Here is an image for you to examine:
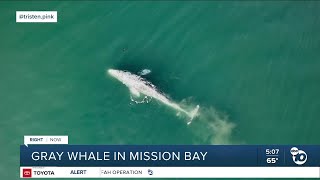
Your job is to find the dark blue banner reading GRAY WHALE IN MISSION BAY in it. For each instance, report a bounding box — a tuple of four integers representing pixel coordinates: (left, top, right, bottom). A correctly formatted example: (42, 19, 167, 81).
(20, 145, 320, 167)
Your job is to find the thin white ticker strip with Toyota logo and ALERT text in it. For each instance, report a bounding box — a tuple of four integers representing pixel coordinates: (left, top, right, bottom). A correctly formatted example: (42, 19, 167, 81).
(20, 167, 320, 178)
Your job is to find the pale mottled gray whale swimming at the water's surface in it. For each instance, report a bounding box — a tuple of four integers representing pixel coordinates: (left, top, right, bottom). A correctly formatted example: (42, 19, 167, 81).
(107, 69, 200, 124)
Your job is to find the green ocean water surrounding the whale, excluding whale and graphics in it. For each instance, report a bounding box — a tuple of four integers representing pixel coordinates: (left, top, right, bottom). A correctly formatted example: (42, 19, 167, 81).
(0, 1, 320, 180)
